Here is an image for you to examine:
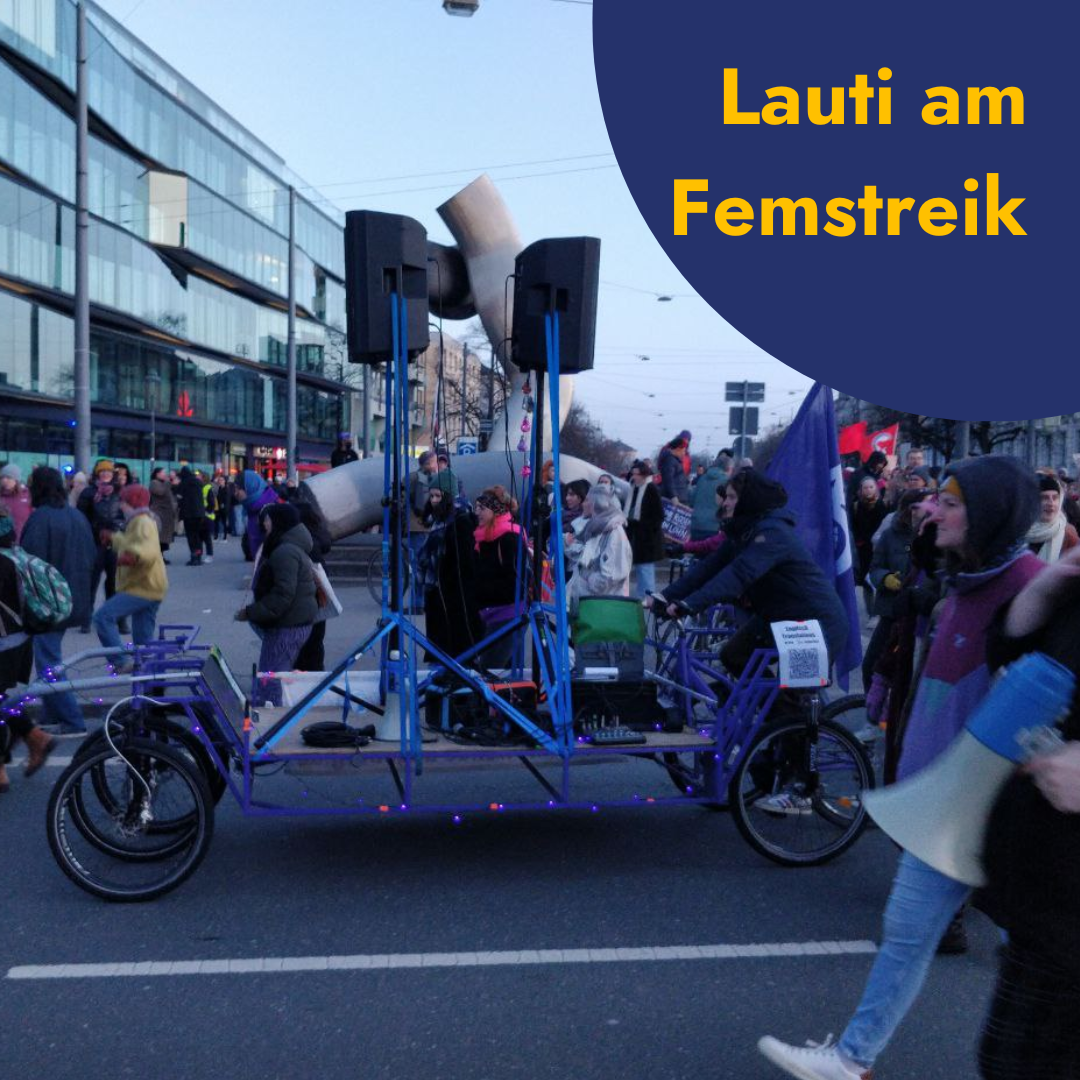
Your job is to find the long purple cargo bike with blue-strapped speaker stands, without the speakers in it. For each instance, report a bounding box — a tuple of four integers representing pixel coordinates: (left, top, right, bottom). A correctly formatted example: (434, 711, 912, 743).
(48, 282, 874, 901)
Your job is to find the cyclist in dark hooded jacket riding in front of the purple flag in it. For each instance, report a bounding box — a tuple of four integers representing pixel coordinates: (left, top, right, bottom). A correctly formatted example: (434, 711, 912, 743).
(645, 468, 849, 674)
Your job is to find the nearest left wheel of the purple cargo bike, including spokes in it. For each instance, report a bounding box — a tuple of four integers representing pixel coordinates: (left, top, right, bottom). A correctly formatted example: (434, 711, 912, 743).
(46, 739, 214, 901)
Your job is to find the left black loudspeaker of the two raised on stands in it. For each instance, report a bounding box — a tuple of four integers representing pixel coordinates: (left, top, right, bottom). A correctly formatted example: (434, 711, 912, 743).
(345, 210, 428, 364)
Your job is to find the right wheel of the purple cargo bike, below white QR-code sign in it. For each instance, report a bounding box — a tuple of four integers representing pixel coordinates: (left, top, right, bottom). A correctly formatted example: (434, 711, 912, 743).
(728, 719, 874, 866)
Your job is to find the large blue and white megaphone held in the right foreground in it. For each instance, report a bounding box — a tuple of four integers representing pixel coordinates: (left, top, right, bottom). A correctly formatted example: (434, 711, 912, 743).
(864, 652, 1076, 888)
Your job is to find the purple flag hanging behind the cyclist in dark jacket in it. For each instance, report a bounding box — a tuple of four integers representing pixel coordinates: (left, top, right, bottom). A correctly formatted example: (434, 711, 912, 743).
(766, 382, 863, 689)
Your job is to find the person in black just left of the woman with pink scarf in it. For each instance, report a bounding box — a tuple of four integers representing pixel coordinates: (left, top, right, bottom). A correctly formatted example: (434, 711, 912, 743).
(416, 487, 484, 660)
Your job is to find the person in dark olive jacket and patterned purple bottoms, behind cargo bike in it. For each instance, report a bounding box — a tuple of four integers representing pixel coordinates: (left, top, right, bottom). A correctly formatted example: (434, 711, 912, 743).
(235, 502, 319, 682)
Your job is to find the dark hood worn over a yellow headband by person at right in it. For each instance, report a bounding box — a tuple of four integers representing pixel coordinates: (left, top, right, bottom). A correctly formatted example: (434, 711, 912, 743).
(950, 454, 1039, 564)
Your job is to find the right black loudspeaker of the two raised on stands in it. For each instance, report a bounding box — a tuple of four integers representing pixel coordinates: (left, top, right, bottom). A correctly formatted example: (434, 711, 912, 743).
(511, 237, 600, 375)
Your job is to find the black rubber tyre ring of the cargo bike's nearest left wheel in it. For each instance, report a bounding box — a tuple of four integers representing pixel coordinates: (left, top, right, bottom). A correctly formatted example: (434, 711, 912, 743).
(46, 739, 214, 903)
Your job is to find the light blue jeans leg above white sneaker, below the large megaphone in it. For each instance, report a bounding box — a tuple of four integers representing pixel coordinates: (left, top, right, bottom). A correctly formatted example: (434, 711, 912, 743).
(839, 851, 971, 1067)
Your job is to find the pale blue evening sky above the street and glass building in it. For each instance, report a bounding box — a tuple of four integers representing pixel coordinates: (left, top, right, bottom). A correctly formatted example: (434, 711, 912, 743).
(97, 0, 811, 454)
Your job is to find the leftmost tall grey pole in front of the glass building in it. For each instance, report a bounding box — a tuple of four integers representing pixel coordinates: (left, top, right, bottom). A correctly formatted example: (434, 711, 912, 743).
(75, 0, 91, 476)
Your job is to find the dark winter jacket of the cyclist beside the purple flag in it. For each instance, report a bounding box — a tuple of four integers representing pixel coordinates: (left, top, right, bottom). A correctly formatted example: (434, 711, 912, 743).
(664, 510, 848, 660)
